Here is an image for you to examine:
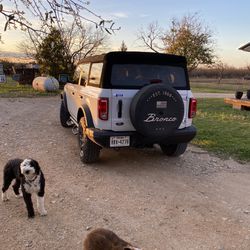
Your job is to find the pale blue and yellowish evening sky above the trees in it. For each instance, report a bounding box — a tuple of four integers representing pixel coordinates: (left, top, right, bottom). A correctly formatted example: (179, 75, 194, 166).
(0, 0, 250, 67)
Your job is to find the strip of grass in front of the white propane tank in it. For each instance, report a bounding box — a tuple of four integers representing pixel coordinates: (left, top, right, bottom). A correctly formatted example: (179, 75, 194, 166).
(0, 77, 59, 98)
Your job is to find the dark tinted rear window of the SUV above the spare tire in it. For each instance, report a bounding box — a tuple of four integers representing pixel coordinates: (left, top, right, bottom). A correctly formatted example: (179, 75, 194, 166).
(111, 64, 187, 88)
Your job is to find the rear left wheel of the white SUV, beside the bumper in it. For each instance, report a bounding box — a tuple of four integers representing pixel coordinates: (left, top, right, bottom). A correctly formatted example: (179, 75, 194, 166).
(78, 117, 101, 163)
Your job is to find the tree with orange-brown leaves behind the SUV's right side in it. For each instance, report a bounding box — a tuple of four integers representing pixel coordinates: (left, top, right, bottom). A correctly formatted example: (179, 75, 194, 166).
(163, 14, 215, 71)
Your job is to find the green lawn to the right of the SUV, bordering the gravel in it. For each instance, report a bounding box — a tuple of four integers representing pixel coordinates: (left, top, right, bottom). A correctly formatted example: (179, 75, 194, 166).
(192, 99, 250, 161)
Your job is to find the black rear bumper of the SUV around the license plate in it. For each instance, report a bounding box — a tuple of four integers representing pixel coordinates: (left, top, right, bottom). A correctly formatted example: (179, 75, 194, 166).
(86, 126, 196, 148)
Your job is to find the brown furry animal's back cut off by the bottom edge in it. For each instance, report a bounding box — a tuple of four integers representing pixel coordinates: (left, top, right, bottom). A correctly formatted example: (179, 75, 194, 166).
(83, 228, 142, 250)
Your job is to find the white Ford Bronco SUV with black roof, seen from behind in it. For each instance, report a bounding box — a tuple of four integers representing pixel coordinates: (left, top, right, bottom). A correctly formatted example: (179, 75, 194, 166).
(60, 52, 196, 163)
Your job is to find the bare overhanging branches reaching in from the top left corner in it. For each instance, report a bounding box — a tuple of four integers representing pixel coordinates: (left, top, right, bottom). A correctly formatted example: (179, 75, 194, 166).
(0, 0, 120, 41)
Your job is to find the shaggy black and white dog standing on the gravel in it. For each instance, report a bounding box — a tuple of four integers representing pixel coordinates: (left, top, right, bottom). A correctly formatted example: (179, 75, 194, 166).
(2, 159, 47, 218)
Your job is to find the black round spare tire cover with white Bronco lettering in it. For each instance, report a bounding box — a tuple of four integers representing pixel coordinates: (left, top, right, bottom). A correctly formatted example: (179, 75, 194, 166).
(130, 84, 184, 137)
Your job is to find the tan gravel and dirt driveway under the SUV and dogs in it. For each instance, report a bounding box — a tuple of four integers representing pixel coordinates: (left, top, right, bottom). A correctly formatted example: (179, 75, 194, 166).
(0, 96, 250, 250)
